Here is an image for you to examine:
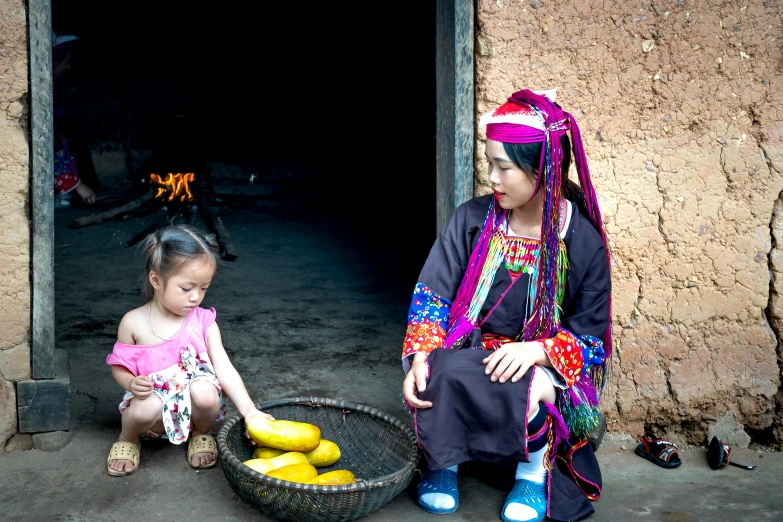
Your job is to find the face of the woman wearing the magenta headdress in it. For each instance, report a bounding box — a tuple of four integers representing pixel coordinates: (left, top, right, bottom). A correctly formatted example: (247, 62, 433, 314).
(486, 138, 535, 210)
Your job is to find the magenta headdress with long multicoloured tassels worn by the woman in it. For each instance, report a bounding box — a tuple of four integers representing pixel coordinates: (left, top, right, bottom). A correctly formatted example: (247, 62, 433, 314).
(446, 89, 612, 360)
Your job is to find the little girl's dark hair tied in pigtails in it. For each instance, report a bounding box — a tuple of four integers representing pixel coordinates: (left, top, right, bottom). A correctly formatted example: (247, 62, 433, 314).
(140, 224, 220, 303)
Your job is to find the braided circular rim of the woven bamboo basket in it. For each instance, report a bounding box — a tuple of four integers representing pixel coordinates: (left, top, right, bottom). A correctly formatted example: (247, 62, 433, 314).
(217, 397, 419, 493)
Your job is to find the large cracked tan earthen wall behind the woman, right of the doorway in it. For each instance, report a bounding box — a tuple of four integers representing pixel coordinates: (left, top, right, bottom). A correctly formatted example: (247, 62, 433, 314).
(476, 0, 783, 443)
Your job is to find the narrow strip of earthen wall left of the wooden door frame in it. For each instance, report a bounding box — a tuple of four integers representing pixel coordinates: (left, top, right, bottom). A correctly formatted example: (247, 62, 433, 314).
(0, 0, 30, 448)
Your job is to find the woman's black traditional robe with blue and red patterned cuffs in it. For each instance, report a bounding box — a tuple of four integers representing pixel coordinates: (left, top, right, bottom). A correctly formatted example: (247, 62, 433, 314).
(403, 195, 611, 520)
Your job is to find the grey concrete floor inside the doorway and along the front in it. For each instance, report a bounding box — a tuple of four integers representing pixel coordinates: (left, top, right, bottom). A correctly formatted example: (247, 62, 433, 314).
(0, 180, 783, 522)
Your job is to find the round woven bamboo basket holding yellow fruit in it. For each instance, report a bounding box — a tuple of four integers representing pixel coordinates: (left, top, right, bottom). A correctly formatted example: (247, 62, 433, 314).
(217, 397, 419, 522)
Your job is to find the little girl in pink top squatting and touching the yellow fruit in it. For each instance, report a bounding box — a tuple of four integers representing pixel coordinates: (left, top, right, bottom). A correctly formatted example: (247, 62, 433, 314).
(106, 221, 274, 477)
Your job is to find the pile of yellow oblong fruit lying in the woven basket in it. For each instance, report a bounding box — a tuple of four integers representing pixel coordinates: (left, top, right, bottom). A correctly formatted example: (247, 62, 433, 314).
(244, 417, 356, 485)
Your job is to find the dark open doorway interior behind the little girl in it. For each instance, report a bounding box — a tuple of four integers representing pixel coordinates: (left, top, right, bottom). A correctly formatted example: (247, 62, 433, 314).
(52, 1, 436, 424)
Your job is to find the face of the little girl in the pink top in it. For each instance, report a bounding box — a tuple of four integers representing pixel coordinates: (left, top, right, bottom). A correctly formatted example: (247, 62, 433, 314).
(150, 255, 215, 316)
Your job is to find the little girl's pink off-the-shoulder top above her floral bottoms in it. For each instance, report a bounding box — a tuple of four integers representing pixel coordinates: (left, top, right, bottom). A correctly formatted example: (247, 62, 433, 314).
(106, 307, 217, 376)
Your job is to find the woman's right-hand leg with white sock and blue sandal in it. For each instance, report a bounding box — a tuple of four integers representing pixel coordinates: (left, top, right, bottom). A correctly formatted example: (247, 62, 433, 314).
(501, 369, 556, 522)
